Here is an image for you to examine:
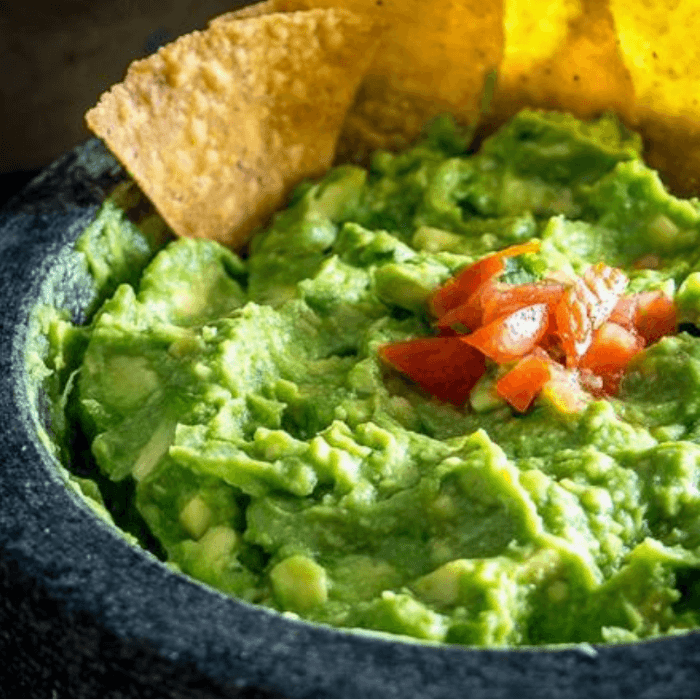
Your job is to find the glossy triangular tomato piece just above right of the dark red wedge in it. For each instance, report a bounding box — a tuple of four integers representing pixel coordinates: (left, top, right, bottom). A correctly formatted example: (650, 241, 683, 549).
(461, 304, 549, 364)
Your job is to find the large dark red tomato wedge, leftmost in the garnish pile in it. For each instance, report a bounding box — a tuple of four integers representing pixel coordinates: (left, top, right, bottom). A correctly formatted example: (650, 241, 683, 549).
(379, 336, 486, 406)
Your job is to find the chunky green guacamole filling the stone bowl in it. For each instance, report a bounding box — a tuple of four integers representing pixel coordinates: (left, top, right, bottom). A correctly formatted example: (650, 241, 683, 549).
(54, 111, 700, 647)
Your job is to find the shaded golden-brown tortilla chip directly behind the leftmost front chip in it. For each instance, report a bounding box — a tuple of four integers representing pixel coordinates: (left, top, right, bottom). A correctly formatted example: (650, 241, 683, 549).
(214, 0, 503, 160)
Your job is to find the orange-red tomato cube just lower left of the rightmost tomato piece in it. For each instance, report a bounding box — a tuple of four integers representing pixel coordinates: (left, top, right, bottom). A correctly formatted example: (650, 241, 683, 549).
(580, 321, 644, 394)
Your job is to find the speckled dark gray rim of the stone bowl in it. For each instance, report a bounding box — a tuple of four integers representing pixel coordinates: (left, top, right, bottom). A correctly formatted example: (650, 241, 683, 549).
(0, 139, 700, 697)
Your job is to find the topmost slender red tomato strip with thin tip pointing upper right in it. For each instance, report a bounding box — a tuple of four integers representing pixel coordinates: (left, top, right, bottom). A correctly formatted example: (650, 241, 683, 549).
(428, 241, 540, 318)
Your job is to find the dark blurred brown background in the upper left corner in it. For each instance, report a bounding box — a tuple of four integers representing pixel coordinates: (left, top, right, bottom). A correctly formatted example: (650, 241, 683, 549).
(0, 0, 251, 206)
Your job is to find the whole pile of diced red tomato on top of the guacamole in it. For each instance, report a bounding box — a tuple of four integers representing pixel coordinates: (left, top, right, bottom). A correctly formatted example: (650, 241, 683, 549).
(379, 246, 677, 413)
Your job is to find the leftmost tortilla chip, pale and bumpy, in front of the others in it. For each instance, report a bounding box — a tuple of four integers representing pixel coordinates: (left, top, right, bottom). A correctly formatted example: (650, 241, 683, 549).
(86, 9, 379, 247)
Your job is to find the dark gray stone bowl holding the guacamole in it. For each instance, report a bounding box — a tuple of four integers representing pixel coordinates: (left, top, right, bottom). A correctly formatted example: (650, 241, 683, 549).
(0, 139, 700, 698)
